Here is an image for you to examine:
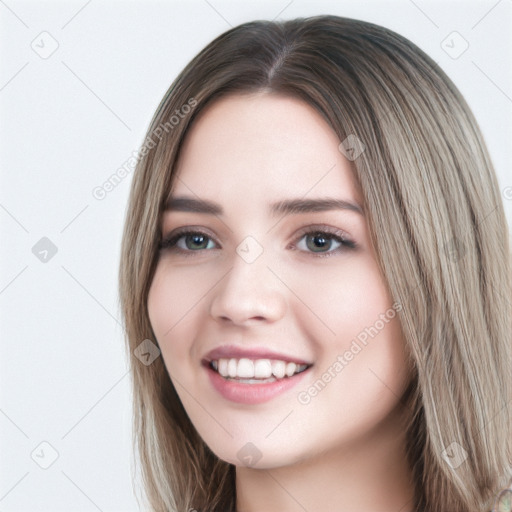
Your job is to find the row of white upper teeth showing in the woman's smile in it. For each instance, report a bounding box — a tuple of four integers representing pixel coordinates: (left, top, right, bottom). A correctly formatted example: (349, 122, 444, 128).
(211, 357, 307, 382)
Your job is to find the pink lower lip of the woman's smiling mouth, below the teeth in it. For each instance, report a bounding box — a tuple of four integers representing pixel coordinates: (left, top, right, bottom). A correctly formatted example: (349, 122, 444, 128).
(206, 366, 309, 404)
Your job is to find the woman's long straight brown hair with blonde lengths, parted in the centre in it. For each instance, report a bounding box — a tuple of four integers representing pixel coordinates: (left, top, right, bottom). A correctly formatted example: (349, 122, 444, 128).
(119, 15, 512, 512)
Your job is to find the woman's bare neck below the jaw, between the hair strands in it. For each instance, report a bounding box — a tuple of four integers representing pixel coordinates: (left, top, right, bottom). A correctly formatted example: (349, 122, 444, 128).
(236, 404, 414, 512)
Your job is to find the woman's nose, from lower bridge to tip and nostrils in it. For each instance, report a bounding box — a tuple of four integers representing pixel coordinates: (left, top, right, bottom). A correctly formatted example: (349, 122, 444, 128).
(210, 247, 287, 325)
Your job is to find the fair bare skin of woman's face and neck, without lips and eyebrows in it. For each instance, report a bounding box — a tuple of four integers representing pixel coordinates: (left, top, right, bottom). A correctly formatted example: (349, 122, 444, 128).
(148, 93, 413, 512)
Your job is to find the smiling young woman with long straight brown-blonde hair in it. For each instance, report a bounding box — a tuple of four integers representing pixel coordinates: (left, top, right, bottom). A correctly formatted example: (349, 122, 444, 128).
(120, 16, 512, 512)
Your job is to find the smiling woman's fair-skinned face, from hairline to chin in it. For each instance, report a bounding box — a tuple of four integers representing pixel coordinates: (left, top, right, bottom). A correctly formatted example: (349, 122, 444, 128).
(148, 93, 410, 468)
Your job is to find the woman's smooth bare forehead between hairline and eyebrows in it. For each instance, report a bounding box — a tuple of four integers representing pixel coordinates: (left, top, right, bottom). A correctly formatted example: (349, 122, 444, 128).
(172, 93, 359, 206)
